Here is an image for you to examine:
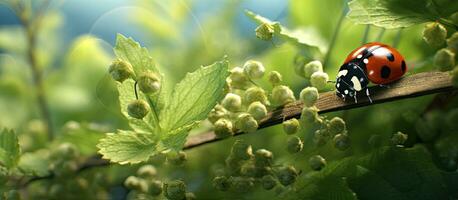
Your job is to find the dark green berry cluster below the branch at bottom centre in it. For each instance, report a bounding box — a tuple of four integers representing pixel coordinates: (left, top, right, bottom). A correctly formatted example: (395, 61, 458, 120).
(213, 140, 299, 193)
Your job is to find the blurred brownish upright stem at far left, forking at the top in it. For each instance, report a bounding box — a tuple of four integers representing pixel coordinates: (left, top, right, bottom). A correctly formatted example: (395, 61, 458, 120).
(16, 1, 54, 140)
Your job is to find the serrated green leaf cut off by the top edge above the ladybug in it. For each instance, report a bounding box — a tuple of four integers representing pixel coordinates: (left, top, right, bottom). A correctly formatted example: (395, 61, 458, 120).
(347, 0, 439, 29)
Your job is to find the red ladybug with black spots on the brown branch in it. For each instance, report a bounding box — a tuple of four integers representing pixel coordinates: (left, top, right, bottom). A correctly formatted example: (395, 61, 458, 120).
(336, 42, 407, 103)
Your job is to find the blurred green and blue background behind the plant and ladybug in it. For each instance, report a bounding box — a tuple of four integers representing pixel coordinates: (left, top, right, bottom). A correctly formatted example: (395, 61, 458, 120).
(0, 0, 454, 199)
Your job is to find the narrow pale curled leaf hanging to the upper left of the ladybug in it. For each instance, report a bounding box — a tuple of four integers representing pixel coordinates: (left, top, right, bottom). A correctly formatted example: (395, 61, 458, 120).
(245, 10, 322, 53)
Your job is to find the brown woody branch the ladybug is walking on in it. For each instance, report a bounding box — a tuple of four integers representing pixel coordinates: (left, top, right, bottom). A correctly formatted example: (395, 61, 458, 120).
(184, 72, 456, 149)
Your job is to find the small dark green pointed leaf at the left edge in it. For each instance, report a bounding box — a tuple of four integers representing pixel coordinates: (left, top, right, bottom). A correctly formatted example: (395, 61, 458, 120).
(0, 129, 21, 169)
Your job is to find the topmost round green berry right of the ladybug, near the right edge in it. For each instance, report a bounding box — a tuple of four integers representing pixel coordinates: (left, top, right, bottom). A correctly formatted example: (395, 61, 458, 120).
(423, 22, 447, 47)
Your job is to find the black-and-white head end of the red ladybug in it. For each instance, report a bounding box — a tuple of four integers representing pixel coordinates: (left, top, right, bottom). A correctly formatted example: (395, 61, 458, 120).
(336, 62, 369, 99)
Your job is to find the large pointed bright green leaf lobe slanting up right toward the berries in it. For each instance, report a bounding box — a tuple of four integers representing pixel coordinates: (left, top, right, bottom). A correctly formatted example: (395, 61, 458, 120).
(160, 60, 229, 132)
